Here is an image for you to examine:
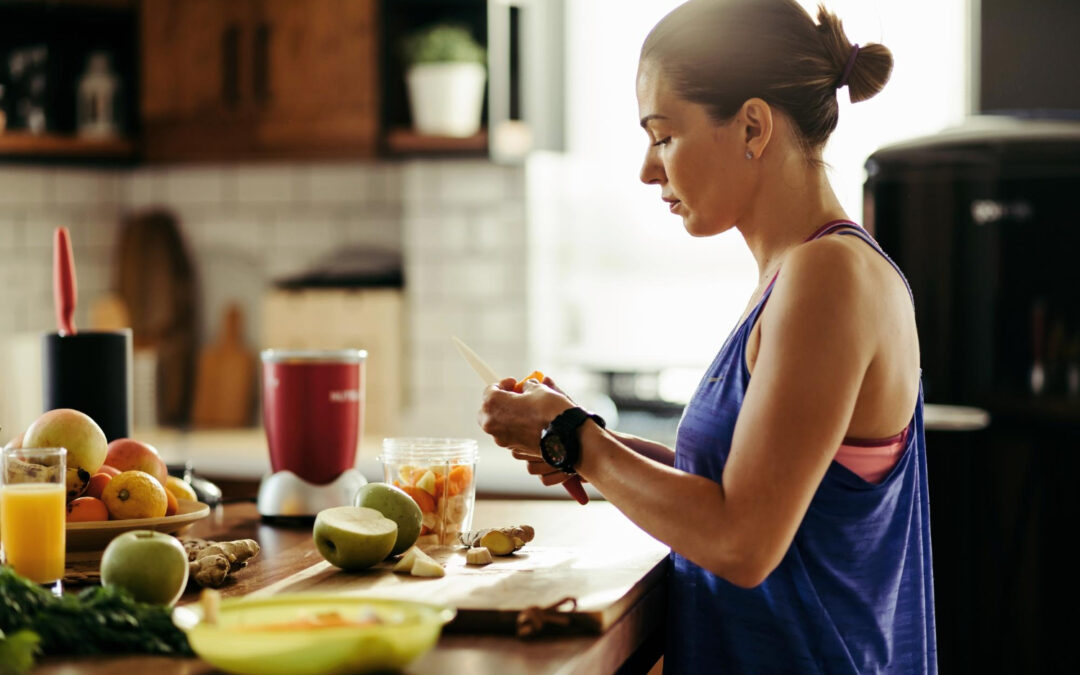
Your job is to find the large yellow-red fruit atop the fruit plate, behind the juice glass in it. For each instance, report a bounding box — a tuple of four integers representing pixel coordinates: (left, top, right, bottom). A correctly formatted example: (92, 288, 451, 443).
(23, 408, 109, 501)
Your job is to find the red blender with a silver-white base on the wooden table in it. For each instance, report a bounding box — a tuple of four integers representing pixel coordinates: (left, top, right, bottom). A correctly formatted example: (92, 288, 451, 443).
(257, 349, 367, 519)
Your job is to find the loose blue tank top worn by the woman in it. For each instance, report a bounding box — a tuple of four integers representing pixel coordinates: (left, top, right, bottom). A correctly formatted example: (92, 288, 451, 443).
(664, 221, 937, 675)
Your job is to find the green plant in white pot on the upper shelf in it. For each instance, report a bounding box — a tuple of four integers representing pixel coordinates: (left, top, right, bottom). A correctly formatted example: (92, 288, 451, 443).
(402, 23, 487, 137)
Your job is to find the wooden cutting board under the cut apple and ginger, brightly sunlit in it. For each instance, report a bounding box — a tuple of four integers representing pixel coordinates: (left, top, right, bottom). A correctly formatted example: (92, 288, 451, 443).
(254, 502, 669, 634)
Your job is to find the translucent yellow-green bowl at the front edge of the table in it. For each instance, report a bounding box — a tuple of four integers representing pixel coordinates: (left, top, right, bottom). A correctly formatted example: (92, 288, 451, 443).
(173, 593, 456, 675)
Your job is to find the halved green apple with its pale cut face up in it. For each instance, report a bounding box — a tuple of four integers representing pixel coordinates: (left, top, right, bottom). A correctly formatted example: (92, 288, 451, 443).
(312, 507, 397, 571)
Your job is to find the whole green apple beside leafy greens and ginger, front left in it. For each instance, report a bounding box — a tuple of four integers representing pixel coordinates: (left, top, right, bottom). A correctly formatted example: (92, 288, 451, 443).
(102, 529, 188, 607)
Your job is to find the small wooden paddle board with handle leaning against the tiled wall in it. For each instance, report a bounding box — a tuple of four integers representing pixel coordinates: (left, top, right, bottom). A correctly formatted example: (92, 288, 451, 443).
(191, 305, 255, 429)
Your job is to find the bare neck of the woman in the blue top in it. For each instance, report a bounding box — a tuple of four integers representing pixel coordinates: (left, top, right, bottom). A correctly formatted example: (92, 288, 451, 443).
(737, 149, 848, 283)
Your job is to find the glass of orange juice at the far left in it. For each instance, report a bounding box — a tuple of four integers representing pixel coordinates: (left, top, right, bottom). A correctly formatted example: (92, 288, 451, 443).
(0, 448, 67, 590)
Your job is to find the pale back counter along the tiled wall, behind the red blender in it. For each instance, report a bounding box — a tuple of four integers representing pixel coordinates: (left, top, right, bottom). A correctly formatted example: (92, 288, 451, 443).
(132, 428, 603, 499)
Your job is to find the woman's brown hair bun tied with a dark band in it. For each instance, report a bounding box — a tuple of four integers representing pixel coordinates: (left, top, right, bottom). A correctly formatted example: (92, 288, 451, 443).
(818, 4, 892, 103)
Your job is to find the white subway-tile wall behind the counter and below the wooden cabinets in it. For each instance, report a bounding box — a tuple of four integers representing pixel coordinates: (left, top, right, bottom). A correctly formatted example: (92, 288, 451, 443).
(0, 160, 528, 437)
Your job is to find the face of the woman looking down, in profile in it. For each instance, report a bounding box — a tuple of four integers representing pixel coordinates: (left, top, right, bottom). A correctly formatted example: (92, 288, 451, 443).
(637, 63, 753, 237)
